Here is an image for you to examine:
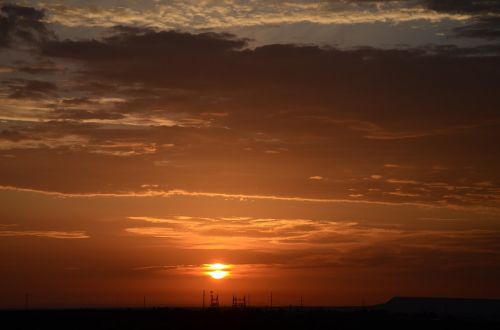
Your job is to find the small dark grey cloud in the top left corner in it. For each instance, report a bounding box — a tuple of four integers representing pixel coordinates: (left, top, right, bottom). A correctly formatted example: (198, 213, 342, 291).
(0, 5, 54, 49)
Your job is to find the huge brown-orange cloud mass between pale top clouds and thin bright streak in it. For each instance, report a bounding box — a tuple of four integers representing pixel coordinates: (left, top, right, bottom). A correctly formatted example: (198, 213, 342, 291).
(0, 15, 500, 208)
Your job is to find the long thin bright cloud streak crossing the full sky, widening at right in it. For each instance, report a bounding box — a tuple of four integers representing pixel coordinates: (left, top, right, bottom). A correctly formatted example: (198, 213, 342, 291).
(0, 165, 500, 217)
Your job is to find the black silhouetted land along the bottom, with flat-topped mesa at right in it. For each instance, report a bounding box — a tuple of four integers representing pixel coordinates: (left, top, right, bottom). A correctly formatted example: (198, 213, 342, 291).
(0, 297, 500, 330)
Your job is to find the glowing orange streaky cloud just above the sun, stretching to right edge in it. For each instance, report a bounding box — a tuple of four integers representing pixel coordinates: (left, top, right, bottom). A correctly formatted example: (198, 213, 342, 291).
(122, 213, 500, 275)
